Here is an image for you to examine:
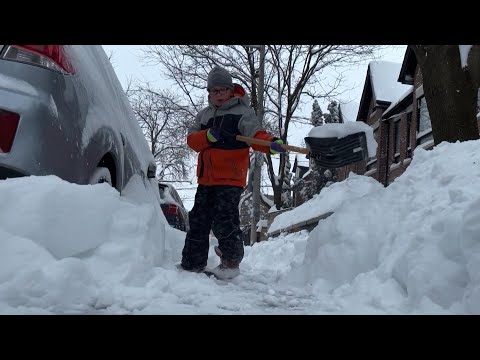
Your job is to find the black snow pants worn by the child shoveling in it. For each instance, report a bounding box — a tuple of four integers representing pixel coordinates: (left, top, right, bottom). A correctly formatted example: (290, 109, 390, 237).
(182, 185, 244, 270)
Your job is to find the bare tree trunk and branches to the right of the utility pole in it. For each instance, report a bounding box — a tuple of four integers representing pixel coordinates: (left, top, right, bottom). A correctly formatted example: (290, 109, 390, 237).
(266, 45, 376, 209)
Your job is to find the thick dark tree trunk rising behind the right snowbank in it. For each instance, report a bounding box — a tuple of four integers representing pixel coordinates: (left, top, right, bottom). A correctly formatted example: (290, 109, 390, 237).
(410, 45, 480, 145)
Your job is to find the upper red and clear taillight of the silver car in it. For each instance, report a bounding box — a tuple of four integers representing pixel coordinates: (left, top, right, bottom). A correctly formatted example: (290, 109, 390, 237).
(2, 45, 75, 74)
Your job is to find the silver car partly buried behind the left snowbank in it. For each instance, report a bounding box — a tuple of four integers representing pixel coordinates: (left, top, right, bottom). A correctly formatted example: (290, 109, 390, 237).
(0, 45, 156, 193)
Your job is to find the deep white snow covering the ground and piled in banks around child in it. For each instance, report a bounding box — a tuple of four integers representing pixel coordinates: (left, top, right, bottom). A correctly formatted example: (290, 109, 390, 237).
(0, 141, 480, 314)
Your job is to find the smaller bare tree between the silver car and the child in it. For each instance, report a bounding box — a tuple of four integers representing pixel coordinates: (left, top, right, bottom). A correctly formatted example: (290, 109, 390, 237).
(126, 81, 197, 181)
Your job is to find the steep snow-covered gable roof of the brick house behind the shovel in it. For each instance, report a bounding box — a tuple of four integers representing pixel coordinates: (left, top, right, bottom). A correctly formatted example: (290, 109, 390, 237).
(368, 61, 410, 102)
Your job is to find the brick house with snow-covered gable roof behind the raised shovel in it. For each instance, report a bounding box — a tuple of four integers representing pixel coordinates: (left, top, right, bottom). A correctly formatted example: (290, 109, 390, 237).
(274, 47, 480, 239)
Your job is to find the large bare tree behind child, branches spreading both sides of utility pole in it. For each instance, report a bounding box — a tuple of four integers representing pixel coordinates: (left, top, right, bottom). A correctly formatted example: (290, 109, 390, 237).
(143, 45, 378, 208)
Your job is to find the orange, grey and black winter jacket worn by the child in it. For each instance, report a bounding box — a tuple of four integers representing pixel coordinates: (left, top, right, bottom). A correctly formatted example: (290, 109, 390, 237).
(187, 84, 274, 187)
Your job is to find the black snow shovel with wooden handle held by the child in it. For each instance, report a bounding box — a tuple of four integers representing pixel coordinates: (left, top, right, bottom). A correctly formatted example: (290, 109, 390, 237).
(236, 131, 368, 169)
